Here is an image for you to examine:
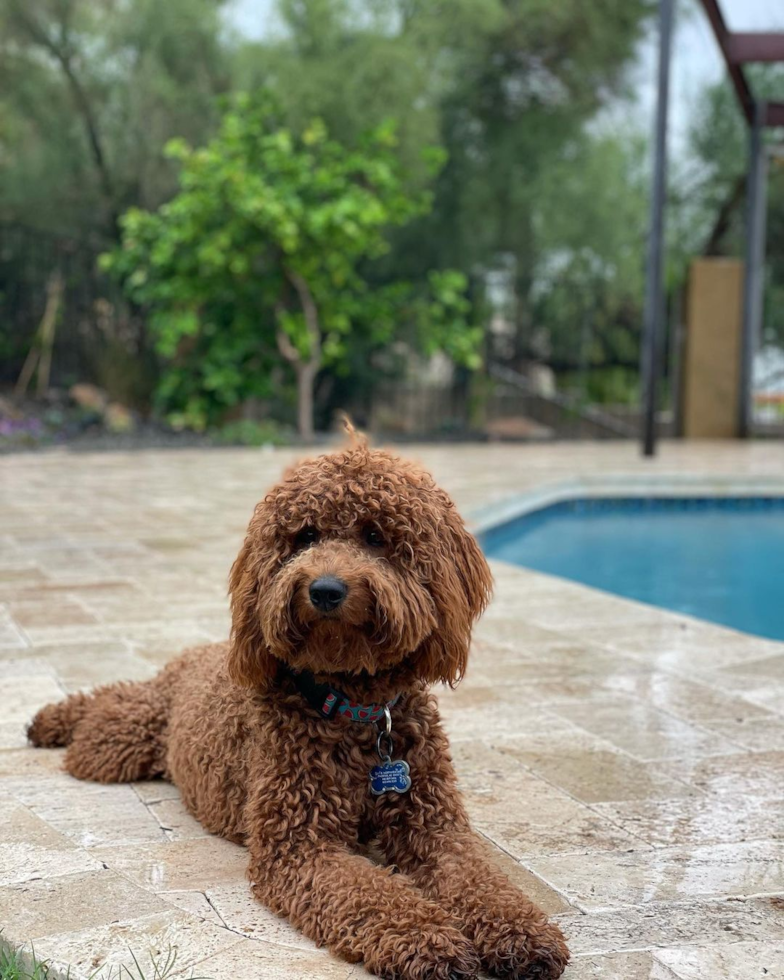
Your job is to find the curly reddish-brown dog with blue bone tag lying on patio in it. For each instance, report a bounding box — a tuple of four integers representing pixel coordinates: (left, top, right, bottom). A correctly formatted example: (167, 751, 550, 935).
(29, 439, 569, 980)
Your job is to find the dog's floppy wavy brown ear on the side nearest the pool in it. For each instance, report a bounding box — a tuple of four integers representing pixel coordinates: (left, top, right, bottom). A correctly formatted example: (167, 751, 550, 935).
(417, 500, 493, 687)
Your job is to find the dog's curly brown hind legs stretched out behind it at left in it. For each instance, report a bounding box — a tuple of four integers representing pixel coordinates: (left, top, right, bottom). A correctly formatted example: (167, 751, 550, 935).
(28, 677, 169, 783)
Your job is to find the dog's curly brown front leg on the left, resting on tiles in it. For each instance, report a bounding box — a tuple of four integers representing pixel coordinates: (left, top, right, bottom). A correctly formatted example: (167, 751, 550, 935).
(249, 835, 479, 980)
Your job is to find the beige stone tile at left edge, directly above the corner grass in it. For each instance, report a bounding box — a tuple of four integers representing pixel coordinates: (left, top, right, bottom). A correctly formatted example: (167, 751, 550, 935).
(0, 869, 165, 943)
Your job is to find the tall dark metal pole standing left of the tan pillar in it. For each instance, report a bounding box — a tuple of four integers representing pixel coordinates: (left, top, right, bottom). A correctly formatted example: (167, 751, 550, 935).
(640, 0, 675, 456)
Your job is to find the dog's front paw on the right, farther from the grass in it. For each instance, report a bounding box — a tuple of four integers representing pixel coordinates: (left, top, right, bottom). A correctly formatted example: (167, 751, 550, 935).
(480, 921, 569, 980)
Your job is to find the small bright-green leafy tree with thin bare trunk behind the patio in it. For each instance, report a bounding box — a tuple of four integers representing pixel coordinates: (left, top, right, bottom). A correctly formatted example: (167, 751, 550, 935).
(104, 96, 474, 439)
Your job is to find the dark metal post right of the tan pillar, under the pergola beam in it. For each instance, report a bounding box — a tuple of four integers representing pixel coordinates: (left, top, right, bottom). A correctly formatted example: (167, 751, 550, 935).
(738, 102, 768, 439)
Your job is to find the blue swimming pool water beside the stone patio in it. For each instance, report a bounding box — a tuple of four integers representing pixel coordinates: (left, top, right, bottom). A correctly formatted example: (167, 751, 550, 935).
(481, 498, 784, 640)
